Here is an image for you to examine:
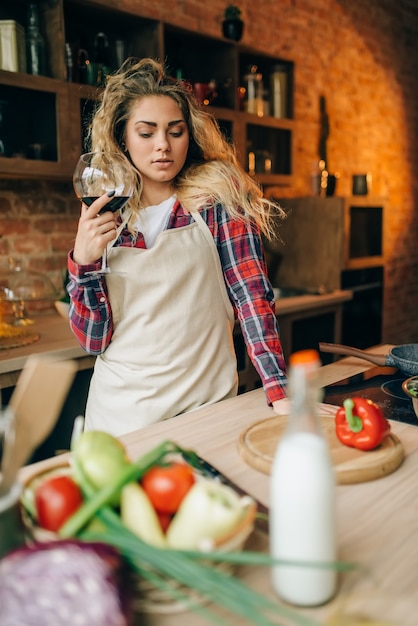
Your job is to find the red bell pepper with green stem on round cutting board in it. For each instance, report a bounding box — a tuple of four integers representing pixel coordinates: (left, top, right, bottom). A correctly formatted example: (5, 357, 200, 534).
(335, 398, 390, 450)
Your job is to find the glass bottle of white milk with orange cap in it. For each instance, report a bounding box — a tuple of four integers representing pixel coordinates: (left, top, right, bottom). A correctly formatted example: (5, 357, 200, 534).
(270, 350, 337, 606)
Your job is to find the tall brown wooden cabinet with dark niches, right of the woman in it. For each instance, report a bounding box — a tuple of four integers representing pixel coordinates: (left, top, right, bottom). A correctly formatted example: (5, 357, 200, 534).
(269, 196, 386, 348)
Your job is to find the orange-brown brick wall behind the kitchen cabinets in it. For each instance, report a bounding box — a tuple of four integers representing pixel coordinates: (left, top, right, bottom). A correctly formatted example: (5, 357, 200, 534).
(0, 0, 418, 343)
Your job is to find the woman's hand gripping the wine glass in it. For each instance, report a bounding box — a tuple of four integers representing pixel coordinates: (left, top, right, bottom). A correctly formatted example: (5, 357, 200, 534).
(73, 193, 117, 265)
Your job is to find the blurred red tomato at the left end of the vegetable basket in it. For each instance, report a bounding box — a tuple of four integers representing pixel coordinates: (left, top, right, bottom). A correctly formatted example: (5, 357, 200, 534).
(35, 475, 83, 532)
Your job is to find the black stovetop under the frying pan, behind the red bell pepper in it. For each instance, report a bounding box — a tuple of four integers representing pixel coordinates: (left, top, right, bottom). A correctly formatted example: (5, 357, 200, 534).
(324, 367, 418, 426)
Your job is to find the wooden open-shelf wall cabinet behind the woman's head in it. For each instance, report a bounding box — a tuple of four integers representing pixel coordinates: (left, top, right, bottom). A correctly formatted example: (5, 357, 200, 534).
(0, 0, 294, 186)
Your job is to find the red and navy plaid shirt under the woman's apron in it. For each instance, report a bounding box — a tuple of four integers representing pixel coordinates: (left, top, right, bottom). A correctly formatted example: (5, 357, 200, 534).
(68, 202, 287, 404)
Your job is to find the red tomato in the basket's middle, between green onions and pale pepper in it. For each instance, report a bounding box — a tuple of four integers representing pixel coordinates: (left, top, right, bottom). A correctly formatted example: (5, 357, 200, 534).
(142, 463, 195, 513)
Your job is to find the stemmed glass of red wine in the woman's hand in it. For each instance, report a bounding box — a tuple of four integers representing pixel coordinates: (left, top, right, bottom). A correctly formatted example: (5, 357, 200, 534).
(73, 152, 134, 274)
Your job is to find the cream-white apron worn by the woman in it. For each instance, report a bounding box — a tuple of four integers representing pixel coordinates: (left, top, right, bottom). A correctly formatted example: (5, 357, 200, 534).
(85, 213, 238, 436)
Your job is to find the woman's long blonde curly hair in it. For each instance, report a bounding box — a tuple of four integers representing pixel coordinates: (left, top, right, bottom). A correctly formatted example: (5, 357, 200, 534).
(89, 58, 284, 238)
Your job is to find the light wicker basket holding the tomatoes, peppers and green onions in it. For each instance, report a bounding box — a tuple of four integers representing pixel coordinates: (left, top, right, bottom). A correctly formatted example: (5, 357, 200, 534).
(21, 463, 257, 614)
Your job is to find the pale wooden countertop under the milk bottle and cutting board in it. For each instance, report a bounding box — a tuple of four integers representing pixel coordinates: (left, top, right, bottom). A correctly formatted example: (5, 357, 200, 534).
(18, 346, 418, 626)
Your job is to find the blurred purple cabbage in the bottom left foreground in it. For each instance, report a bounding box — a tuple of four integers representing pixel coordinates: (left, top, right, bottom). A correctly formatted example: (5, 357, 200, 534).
(0, 540, 131, 626)
